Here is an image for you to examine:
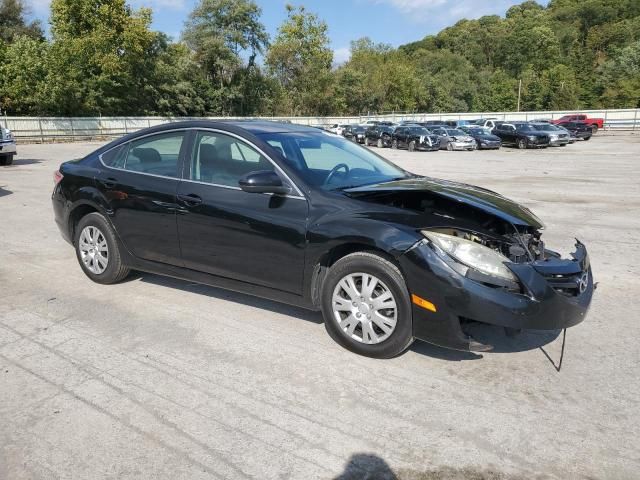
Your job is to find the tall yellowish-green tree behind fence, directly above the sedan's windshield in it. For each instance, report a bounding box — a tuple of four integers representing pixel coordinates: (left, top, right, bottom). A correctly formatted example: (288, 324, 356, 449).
(266, 5, 335, 115)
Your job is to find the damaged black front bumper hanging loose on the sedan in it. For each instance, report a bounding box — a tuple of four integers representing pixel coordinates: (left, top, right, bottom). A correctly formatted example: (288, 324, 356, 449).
(400, 241, 594, 350)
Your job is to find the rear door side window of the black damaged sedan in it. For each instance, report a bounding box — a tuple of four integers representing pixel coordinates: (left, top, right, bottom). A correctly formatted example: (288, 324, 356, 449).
(120, 132, 185, 178)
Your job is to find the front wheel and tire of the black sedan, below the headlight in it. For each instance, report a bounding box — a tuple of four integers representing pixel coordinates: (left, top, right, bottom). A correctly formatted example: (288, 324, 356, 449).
(321, 252, 413, 358)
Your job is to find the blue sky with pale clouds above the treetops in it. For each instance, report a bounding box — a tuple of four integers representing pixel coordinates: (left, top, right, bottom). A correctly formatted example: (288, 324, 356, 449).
(26, 0, 546, 63)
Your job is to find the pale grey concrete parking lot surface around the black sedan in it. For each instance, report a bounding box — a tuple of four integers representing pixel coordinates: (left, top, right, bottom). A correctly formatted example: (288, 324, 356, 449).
(0, 135, 640, 480)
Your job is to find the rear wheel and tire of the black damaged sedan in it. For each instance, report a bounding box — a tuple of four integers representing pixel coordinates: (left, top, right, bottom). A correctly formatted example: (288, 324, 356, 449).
(74, 213, 129, 285)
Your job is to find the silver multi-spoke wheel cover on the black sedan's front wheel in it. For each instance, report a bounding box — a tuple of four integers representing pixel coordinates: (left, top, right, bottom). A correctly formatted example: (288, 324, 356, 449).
(331, 273, 398, 344)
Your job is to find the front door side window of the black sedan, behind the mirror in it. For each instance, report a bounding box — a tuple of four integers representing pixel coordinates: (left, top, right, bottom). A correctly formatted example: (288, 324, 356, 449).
(189, 132, 274, 187)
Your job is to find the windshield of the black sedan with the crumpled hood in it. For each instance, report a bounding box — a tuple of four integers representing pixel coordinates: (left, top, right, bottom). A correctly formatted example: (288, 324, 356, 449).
(259, 131, 412, 190)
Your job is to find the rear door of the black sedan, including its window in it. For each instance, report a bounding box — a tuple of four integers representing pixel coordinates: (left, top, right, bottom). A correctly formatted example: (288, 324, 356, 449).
(96, 130, 187, 265)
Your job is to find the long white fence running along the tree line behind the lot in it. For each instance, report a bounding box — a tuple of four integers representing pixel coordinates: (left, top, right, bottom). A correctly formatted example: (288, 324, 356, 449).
(0, 109, 640, 142)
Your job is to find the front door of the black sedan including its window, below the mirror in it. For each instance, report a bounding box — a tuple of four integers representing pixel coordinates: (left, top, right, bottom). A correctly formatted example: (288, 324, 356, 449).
(178, 131, 308, 294)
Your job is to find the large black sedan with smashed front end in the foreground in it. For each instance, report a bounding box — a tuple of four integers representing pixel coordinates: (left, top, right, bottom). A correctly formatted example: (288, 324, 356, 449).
(52, 121, 594, 357)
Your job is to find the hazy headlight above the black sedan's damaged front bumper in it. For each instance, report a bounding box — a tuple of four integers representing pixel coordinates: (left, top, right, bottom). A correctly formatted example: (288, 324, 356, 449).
(422, 230, 518, 282)
